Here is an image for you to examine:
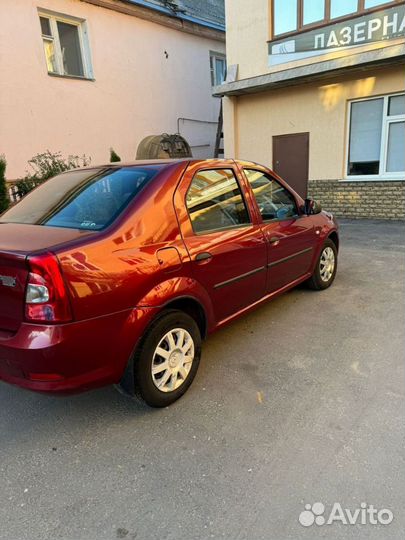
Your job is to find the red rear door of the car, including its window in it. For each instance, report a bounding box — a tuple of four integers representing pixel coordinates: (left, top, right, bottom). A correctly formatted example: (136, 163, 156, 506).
(174, 162, 267, 322)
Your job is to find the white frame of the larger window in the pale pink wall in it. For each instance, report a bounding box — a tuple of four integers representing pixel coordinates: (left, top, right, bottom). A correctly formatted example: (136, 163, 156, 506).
(38, 9, 94, 79)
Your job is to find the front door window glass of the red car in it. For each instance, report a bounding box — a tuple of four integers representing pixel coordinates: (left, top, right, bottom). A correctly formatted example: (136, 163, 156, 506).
(245, 169, 298, 221)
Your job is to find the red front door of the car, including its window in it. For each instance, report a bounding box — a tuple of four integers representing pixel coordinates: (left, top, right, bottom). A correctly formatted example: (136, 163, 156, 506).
(244, 168, 318, 293)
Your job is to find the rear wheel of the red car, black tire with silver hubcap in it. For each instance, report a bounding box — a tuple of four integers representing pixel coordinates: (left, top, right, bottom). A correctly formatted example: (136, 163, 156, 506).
(133, 310, 201, 407)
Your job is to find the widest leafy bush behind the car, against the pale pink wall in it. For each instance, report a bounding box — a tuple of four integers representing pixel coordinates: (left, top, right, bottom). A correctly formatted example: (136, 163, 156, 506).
(16, 150, 90, 197)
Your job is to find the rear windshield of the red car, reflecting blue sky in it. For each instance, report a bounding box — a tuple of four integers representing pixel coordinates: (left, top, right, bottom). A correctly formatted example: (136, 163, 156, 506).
(0, 165, 162, 230)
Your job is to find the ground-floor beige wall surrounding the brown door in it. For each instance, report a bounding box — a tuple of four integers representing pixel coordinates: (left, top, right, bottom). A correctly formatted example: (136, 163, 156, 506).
(225, 66, 405, 180)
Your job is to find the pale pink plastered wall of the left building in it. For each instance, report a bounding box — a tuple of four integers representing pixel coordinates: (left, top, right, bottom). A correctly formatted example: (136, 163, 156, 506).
(0, 0, 225, 179)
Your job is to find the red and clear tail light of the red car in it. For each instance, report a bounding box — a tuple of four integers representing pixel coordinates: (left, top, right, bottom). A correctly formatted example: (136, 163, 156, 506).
(25, 253, 72, 323)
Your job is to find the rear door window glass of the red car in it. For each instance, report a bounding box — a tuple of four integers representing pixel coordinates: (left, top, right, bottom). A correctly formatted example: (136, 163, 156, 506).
(186, 169, 250, 234)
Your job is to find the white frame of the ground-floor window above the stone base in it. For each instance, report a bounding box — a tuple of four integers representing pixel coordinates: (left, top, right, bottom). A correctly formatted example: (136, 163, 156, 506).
(344, 92, 405, 182)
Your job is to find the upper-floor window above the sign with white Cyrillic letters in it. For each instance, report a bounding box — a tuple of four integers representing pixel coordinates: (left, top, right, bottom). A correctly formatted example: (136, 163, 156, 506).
(272, 0, 403, 37)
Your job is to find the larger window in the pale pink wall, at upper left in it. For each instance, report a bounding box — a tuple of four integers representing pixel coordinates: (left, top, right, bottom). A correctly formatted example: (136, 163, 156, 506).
(39, 12, 93, 79)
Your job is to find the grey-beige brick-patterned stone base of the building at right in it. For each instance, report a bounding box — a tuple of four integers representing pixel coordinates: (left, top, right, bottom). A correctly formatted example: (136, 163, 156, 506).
(308, 180, 405, 221)
